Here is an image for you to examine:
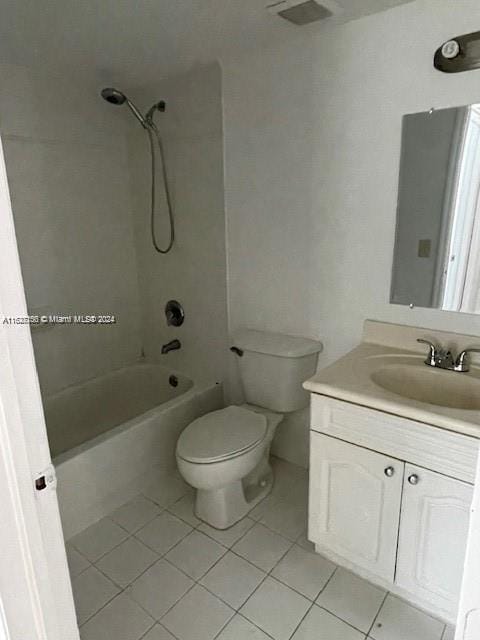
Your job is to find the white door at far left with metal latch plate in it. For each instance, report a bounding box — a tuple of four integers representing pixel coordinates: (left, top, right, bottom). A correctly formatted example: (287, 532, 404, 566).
(0, 134, 79, 640)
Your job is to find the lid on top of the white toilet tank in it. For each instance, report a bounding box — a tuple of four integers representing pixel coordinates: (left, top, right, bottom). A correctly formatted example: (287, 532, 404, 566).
(233, 329, 323, 358)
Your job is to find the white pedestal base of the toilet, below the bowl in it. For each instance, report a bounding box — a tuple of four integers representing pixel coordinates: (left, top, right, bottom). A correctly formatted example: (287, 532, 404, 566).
(195, 455, 273, 529)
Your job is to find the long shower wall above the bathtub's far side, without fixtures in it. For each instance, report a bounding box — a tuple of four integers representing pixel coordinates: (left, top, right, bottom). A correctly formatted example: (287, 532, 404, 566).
(0, 64, 141, 394)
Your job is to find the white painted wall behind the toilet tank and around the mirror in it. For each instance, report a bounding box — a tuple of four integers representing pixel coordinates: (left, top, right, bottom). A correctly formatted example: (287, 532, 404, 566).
(222, 0, 480, 459)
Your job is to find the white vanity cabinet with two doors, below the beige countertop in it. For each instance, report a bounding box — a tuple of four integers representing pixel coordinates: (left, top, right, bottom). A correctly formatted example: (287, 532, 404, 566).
(308, 395, 478, 621)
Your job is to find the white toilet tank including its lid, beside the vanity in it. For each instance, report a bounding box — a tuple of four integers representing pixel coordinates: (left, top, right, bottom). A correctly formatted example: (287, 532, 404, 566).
(234, 329, 323, 413)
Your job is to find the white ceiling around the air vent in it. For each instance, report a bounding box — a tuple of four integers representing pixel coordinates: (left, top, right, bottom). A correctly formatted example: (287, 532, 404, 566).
(0, 0, 412, 86)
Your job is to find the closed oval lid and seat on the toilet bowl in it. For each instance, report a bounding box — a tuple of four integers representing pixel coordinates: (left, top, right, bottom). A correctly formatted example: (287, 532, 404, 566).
(177, 406, 267, 463)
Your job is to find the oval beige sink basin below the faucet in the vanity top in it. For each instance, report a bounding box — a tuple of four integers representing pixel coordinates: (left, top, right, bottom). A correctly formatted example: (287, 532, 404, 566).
(370, 363, 480, 411)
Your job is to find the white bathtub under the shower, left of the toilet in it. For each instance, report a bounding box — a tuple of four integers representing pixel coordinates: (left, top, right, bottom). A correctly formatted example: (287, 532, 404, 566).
(44, 363, 223, 539)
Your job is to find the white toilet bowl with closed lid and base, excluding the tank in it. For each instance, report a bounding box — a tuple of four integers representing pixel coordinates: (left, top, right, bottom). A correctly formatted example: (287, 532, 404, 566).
(176, 405, 283, 529)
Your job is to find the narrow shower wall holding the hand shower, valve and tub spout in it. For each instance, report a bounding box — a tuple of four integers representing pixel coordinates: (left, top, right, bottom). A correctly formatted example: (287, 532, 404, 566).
(126, 65, 230, 388)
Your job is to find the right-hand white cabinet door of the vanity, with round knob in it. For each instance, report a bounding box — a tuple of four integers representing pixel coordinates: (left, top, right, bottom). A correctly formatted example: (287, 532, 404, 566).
(395, 464, 473, 618)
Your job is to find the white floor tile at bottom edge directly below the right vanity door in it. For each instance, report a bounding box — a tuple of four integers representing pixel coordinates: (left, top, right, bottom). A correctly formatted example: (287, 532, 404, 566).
(370, 594, 444, 640)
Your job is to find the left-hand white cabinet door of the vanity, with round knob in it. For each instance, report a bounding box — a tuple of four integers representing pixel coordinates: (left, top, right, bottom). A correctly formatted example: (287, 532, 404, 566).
(309, 431, 404, 581)
